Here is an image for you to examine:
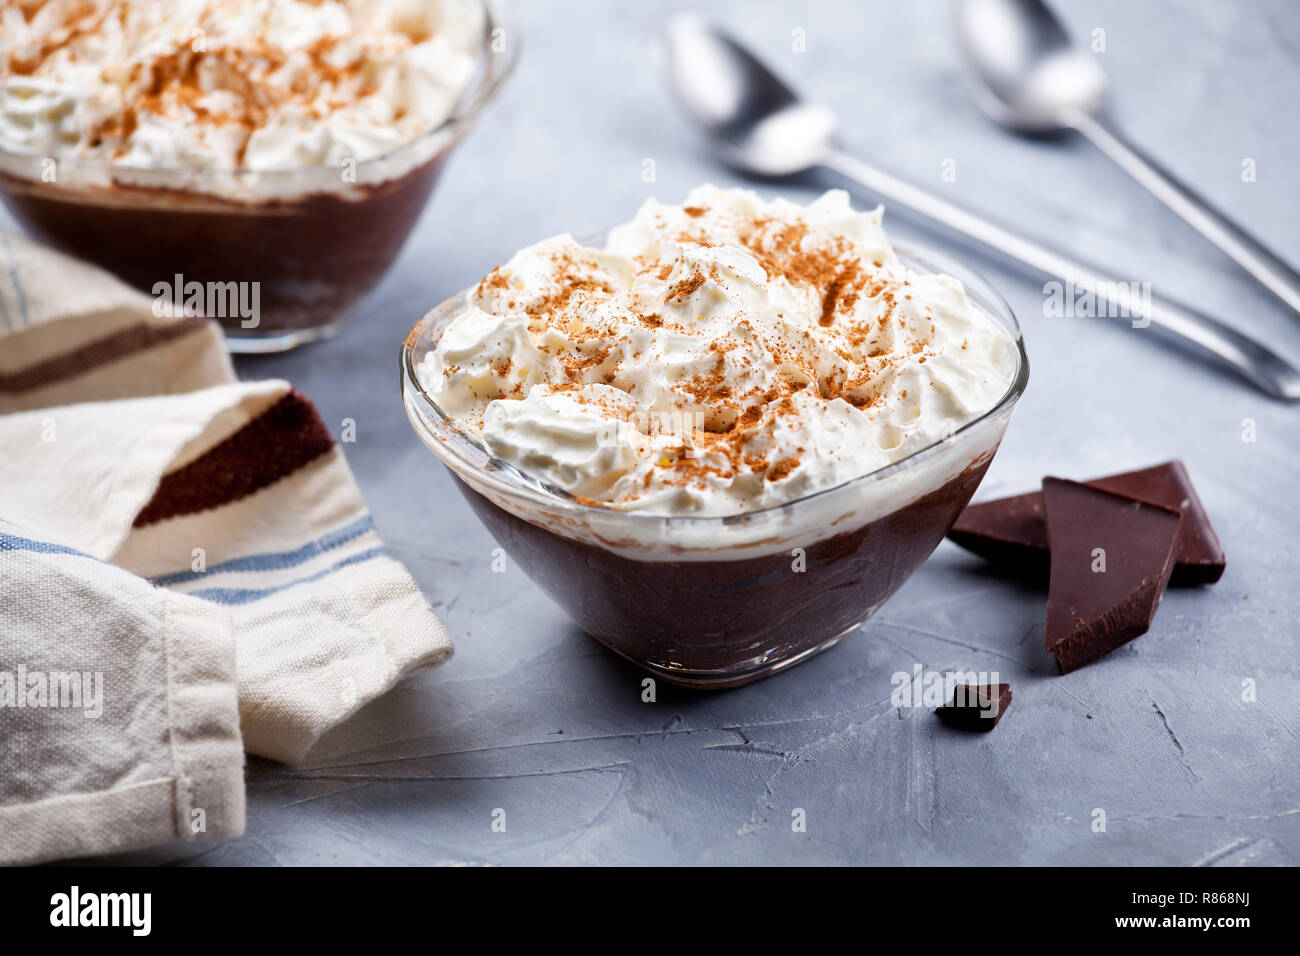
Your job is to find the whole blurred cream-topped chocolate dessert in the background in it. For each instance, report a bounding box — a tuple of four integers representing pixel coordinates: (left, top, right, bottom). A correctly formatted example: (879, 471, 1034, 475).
(0, 0, 489, 350)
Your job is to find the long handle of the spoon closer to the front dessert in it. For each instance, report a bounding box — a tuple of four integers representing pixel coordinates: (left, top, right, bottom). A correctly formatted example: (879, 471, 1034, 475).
(823, 150, 1300, 401)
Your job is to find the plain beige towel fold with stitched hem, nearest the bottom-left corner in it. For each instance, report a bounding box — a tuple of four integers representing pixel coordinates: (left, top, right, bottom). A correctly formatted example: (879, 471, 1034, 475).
(0, 520, 244, 864)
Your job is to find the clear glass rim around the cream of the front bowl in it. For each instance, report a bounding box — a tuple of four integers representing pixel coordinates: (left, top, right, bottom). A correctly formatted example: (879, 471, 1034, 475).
(399, 230, 1030, 528)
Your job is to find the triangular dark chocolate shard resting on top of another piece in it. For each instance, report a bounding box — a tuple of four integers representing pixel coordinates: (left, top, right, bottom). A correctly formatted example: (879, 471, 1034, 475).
(1043, 477, 1182, 674)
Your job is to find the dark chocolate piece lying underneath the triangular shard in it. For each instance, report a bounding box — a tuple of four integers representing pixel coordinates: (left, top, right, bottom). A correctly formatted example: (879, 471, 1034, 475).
(948, 460, 1226, 587)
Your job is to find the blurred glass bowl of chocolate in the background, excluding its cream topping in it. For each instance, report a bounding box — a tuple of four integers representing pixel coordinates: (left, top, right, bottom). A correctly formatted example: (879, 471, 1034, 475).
(0, 0, 519, 352)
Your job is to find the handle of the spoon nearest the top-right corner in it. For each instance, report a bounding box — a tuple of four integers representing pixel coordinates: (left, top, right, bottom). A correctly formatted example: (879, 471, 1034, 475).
(1069, 112, 1300, 312)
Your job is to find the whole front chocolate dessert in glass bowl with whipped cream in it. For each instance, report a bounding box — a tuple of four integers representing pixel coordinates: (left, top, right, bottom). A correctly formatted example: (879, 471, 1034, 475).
(404, 186, 1026, 687)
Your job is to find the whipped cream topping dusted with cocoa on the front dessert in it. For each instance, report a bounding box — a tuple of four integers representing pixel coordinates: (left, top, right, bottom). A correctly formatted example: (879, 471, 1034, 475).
(419, 186, 1018, 515)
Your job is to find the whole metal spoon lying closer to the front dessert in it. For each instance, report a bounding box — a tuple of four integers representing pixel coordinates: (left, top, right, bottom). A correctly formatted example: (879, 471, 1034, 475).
(658, 13, 1300, 399)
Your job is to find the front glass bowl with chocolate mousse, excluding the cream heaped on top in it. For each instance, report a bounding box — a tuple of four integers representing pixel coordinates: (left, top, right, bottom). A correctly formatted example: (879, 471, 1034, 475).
(402, 239, 1030, 687)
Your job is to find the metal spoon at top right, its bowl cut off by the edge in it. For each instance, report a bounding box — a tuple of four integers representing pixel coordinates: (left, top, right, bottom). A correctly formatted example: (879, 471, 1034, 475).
(957, 0, 1300, 312)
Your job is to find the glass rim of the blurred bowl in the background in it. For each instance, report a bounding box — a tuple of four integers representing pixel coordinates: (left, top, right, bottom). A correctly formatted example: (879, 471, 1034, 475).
(0, 0, 520, 183)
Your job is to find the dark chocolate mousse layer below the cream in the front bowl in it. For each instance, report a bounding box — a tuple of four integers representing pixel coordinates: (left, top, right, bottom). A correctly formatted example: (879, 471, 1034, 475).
(458, 460, 988, 687)
